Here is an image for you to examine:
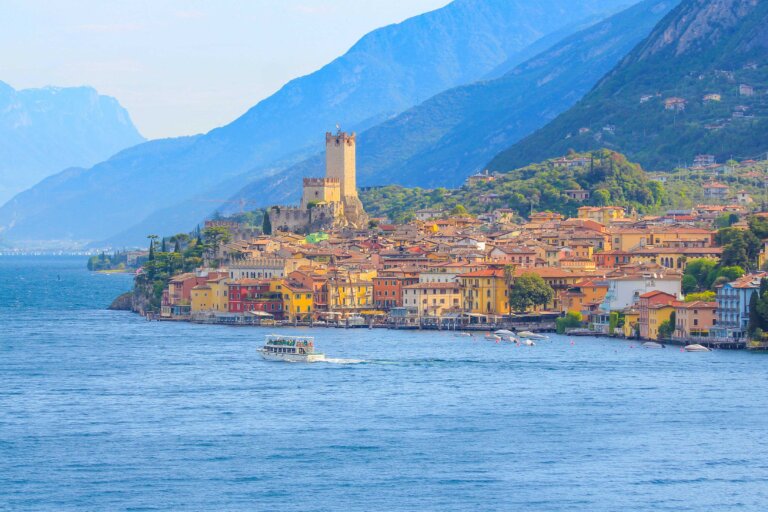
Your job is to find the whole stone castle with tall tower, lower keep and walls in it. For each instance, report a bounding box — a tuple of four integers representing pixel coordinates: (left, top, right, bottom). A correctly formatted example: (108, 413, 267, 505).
(269, 130, 368, 233)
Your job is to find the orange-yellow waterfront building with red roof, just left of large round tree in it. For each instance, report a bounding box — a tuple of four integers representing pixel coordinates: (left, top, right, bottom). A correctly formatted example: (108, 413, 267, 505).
(459, 268, 510, 315)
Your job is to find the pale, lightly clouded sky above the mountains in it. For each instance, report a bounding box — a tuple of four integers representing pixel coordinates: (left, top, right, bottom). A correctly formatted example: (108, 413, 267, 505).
(0, 0, 449, 139)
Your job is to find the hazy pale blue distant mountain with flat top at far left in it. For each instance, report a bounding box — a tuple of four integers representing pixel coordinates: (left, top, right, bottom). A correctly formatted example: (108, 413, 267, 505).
(0, 82, 144, 204)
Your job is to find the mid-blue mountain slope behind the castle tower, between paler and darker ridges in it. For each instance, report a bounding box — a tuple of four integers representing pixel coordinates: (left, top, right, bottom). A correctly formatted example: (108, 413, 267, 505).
(231, 0, 678, 203)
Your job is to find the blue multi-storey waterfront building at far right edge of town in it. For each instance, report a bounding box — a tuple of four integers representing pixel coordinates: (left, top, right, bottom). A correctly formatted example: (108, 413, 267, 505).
(711, 272, 768, 339)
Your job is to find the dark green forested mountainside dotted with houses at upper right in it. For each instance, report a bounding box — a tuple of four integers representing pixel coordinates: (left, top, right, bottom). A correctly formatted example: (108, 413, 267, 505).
(490, 0, 768, 170)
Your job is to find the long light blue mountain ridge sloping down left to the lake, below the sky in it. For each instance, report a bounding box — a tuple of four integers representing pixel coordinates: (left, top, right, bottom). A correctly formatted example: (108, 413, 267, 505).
(0, 0, 626, 248)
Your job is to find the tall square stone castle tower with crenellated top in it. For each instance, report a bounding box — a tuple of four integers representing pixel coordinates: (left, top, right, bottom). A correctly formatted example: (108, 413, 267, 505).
(325, 130, 368, 228)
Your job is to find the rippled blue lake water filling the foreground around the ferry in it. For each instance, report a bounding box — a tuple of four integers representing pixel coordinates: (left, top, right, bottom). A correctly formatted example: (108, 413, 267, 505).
(0, 257, 768, 511)
